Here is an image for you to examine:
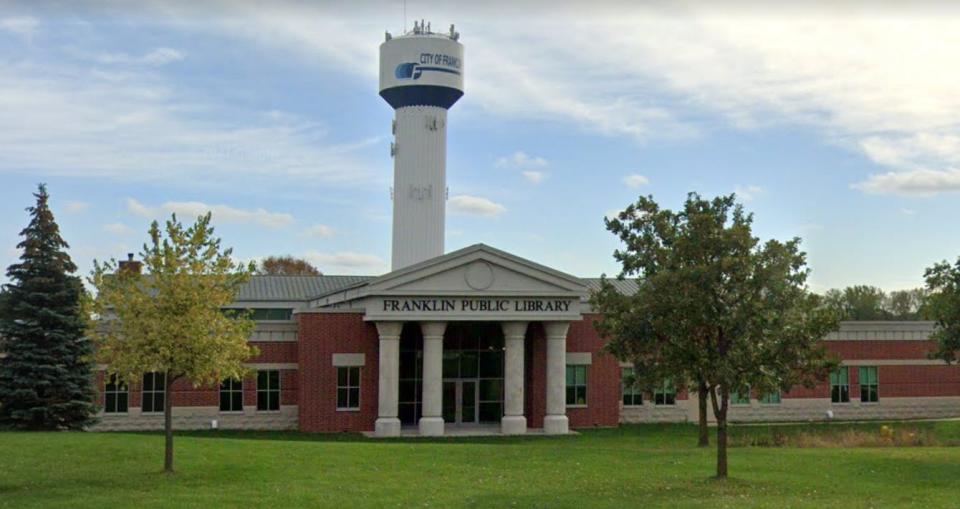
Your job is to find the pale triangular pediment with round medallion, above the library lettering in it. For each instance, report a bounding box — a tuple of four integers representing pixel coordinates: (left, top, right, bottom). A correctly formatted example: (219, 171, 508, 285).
(364, 244, 587, 297)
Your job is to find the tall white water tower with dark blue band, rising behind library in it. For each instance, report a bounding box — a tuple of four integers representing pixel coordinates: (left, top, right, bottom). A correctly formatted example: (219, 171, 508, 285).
(380, 21, 463, 270)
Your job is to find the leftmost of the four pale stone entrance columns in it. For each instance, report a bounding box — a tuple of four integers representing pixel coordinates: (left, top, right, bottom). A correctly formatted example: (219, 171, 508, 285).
(374, 322, 403, 437)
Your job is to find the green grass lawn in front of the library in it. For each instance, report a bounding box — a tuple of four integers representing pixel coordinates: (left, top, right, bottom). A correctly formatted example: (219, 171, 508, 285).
(0, 422, 960, 509)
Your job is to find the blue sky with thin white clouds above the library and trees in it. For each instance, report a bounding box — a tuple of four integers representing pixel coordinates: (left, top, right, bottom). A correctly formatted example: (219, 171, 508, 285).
(0, 0, 960, 291)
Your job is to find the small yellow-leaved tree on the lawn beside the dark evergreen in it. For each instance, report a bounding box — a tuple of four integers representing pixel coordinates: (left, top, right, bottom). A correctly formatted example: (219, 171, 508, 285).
(88, 214, 257, 472)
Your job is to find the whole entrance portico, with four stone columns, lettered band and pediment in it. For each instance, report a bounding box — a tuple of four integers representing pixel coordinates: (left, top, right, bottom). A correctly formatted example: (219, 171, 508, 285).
(315, 244, 587, 437)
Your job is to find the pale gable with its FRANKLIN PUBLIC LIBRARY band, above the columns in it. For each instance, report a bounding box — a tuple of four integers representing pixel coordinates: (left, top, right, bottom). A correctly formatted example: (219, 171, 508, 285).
(311, 244, 587, 322)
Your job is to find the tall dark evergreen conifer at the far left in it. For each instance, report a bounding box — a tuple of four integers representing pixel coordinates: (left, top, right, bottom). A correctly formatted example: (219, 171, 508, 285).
(0, 184, 96, 430)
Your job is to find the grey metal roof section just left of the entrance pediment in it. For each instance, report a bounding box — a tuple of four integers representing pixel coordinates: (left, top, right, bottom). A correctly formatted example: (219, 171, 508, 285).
(236, 276, 373, 302)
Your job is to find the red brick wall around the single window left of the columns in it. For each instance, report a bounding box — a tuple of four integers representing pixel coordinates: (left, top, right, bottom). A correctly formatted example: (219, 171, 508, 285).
(297, 313, 379, 432)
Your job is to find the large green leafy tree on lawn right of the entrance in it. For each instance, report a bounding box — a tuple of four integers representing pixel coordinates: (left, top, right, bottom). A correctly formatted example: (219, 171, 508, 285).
(593, 193, 837, 478)
